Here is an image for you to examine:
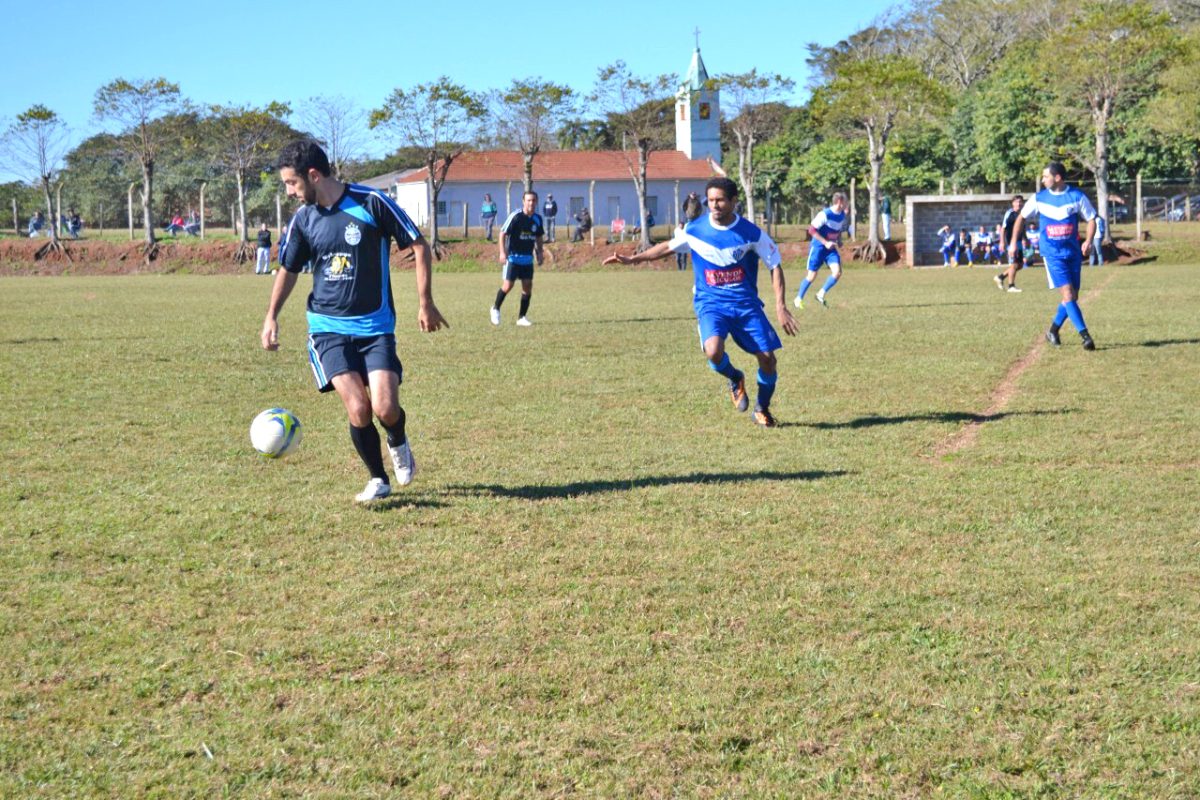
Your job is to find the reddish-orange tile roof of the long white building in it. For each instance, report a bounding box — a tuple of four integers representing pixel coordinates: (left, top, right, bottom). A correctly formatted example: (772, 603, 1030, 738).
(401, 150, 714, 184)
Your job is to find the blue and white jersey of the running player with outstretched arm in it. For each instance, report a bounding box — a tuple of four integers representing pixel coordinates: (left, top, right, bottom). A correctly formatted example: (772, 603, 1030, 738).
(670, 213, 782, 308)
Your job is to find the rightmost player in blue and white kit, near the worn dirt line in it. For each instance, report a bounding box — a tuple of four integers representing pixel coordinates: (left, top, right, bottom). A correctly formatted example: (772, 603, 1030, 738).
(1009, 161, 1096, 350)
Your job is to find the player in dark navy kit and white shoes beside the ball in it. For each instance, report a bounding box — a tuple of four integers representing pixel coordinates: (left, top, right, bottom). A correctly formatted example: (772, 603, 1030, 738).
(262, 140, 449, 503)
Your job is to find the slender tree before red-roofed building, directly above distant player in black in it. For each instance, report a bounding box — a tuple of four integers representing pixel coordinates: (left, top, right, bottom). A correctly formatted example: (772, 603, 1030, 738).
(492, 78, 575, 192)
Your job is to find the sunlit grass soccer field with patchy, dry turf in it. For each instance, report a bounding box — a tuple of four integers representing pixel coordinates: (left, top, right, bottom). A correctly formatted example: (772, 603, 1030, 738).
(0, 264, 1200, 799)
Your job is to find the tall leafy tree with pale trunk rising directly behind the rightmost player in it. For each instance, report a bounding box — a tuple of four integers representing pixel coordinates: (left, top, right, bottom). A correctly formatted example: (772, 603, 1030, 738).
(1039, 0, 1181, 231)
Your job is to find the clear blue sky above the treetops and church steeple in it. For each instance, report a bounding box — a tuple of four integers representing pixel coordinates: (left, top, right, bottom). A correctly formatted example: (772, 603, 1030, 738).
(0, 0, 892, 175)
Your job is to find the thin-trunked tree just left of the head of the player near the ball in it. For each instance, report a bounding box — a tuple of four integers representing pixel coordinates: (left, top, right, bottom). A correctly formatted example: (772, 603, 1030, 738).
(206, 103, 294, 264)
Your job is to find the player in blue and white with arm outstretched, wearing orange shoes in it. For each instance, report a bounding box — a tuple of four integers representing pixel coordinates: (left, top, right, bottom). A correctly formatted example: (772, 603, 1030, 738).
(604, 178, 797, 428)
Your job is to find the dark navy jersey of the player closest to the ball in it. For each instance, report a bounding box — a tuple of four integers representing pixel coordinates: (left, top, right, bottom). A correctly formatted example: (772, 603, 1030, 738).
(280, 184, 421, 336)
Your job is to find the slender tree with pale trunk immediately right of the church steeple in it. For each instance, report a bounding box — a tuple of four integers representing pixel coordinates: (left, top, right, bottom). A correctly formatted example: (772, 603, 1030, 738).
(715, 70, 796, 219)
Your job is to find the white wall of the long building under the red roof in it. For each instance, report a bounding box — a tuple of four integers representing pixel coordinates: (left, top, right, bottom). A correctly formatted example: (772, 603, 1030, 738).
(395, 173, 707, 230)
